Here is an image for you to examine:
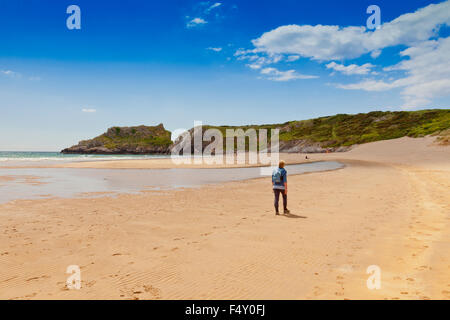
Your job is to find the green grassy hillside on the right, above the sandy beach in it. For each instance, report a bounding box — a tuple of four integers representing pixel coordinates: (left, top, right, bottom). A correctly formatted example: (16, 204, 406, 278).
(199, 109, 450, 148)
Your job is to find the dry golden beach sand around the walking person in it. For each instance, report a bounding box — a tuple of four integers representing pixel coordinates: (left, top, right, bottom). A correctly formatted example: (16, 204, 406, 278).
(0, 138, 450, 299)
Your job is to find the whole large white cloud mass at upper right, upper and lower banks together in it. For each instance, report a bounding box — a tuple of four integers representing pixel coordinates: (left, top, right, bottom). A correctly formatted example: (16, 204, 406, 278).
(243, 0, 450, 109)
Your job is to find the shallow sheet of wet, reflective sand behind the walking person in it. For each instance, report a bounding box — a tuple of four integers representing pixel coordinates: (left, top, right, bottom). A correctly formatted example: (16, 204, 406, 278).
(0, 161, 343, 204)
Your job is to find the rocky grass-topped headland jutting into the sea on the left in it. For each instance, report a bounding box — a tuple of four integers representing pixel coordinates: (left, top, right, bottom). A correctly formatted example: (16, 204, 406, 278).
(61, 124, 172, 154)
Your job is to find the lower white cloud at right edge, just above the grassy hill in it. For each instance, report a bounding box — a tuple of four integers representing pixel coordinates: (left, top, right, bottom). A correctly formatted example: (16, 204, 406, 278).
(337, 37, 450, 109)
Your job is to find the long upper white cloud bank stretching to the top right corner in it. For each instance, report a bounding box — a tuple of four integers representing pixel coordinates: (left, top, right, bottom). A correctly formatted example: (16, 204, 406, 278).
(252, 1, 450, 61)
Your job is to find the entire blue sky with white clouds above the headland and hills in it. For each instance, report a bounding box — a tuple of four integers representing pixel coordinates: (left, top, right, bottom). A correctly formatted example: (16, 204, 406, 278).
(0, 0, 450, 151)
